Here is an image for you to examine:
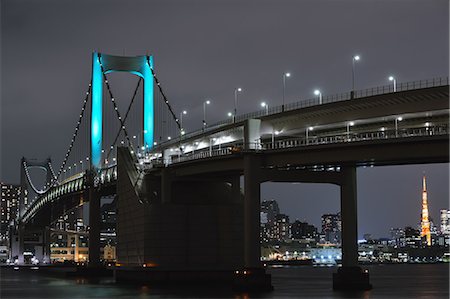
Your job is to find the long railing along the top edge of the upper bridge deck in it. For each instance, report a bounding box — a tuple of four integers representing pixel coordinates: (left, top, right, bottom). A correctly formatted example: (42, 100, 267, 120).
(155, 77, 449, 150)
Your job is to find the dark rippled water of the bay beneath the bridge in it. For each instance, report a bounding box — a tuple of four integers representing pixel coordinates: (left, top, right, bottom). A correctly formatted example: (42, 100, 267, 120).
(0, 264, 449, 299)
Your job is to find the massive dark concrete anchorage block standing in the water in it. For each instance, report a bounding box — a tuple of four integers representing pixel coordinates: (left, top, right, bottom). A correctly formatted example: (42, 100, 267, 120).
(116, 150, 253, 288)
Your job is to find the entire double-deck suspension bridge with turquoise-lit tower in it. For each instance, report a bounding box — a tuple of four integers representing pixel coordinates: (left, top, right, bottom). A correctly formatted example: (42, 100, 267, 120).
(9, 53, 449, 289)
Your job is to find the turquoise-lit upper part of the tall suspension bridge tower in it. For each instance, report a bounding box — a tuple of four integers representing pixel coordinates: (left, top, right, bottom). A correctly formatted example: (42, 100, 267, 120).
(90, 52, 154, 169)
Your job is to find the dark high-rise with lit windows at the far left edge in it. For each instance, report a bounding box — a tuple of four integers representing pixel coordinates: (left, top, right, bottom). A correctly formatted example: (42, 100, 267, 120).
(0, 183, 22, 241)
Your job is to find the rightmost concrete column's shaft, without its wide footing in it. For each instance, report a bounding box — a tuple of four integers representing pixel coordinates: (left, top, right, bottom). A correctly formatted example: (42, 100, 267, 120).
(341, 166, 358, 267)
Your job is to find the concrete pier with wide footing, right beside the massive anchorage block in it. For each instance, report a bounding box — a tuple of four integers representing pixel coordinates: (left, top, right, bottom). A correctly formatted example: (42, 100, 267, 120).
(234, 154, 273, 291)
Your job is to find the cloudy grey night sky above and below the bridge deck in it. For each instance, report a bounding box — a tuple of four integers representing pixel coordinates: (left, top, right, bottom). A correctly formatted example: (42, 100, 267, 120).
(0, 0, 449, 236)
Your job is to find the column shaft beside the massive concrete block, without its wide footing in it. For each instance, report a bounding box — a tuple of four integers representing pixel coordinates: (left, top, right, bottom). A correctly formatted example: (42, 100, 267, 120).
(244, 154, 262, 268)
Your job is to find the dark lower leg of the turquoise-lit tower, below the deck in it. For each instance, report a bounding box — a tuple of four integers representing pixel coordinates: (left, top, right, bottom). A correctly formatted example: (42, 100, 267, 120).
(89, 186, 101, 267)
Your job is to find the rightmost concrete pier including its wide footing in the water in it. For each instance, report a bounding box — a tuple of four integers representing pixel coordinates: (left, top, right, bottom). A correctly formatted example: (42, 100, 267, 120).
(333, 166, 372, 290)
